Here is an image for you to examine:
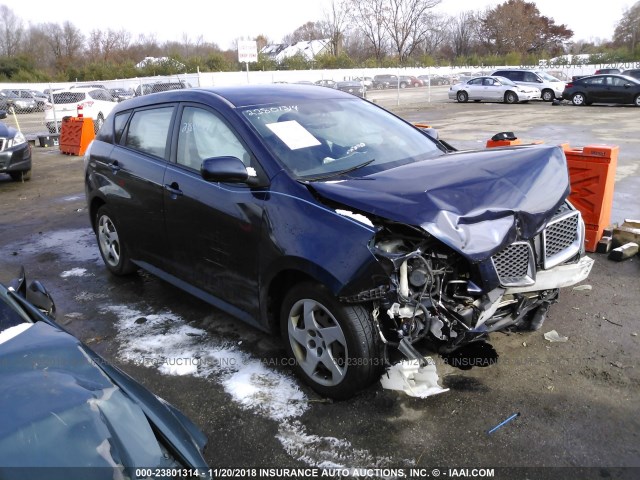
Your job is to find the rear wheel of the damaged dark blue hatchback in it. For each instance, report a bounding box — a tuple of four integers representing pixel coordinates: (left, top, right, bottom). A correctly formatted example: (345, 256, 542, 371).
(95, 205, 136, 275)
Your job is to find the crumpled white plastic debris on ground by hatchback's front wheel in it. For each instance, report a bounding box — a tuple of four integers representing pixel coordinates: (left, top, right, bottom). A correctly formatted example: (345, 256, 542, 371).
(380, 357, 449, 398)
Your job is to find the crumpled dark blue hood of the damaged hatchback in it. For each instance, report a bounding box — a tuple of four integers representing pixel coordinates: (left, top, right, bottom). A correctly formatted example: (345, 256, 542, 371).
(309, 145, 570, 261)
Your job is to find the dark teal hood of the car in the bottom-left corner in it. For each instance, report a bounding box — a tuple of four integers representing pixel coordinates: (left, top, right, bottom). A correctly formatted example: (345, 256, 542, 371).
(0, 322, 166, 479)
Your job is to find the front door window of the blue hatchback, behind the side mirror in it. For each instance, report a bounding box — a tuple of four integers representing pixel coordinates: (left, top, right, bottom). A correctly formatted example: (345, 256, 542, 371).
(176, 107, 251, 170)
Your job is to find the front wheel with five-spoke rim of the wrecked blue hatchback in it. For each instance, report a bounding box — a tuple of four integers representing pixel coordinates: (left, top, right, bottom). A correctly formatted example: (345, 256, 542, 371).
(281, 283, 383, 399)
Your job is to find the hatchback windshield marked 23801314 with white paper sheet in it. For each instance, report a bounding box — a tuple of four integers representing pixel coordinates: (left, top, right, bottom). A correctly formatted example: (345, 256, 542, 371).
(242, 98, 444, 180)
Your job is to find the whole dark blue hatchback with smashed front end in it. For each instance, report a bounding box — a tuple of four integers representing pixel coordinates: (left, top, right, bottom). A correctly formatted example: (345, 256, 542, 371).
(85, 85, 593, 398)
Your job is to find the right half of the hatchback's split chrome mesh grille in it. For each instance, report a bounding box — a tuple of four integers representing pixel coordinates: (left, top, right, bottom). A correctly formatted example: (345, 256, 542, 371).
(542, 210, 581, 269)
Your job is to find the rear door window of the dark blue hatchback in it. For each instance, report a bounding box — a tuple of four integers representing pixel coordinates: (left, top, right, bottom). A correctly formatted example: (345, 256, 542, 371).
(125, 107, 174, 158)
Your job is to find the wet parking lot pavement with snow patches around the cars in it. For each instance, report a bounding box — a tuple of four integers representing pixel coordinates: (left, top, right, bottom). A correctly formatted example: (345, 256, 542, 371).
(0, 87, 640, 479)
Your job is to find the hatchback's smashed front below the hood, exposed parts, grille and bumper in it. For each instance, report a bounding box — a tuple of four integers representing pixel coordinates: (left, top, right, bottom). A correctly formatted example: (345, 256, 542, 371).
(343, 203, 593, 363)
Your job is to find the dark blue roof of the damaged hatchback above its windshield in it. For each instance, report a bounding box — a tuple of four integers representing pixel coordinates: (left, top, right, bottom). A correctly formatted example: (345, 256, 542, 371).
(112, 84, 356, 110)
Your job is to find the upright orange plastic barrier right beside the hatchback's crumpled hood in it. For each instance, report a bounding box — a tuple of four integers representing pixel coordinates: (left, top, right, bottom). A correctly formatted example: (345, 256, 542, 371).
(562, 144, 620, 252)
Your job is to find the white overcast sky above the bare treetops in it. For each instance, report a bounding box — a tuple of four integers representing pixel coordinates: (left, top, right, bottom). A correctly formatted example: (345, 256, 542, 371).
(0, 0, 635, 49)
